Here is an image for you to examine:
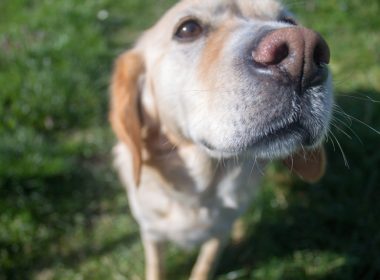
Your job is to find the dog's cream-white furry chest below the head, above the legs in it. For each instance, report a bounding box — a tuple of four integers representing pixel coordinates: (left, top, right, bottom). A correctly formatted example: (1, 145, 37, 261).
(115, 143, 260, 247)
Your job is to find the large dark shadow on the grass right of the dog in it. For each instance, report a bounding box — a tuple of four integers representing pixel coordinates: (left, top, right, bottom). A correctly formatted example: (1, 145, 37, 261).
(218, 90, 380, 280)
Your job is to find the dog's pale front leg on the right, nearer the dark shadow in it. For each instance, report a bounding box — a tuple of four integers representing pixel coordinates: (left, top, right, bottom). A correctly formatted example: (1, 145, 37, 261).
(190, 237, 224, 280)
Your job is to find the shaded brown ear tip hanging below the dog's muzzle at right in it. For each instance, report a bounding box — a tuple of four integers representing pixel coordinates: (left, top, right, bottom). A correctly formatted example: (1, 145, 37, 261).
(283, 146, 326, 183)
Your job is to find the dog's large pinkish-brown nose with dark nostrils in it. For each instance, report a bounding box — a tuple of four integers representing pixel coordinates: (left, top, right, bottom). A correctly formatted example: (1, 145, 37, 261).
(252, 27, 330, 88)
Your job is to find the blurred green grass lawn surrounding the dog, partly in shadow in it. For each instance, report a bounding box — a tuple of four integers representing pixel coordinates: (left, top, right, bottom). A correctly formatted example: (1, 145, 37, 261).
(0, 0, 380, 280)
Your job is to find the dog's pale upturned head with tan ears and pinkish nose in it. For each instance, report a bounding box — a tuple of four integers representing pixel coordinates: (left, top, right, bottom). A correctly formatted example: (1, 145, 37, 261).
(110, 0, 332, 186)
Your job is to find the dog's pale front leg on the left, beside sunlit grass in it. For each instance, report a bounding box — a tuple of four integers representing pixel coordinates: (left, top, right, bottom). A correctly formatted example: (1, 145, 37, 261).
(143, 238, 165, 280)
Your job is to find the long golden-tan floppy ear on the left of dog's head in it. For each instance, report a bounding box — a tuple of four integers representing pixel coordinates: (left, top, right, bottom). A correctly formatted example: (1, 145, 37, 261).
(109, 50, 145, 186)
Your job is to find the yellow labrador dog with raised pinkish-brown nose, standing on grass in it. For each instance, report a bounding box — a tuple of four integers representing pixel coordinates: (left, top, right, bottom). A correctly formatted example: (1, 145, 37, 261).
(110, 0, 333, 280)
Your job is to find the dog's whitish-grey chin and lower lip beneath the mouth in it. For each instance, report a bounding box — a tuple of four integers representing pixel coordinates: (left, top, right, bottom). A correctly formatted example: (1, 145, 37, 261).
(200, 123, 324, 159)
